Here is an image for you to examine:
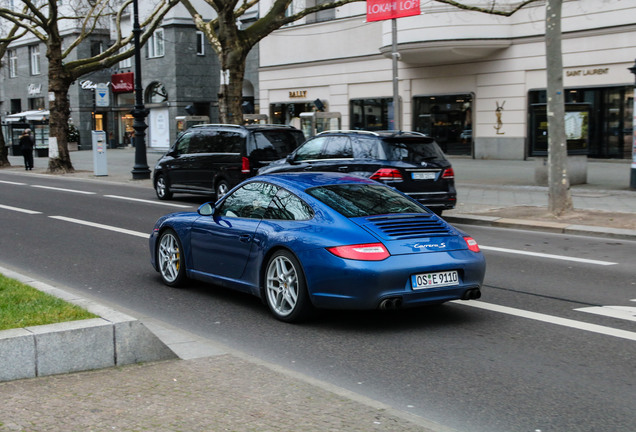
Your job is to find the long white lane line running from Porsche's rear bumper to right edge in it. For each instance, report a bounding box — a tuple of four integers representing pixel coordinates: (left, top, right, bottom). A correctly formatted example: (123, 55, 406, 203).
(453, 300, 636, 341)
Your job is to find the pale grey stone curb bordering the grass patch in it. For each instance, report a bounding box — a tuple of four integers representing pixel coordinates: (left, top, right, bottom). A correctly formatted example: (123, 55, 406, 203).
(0, 267, 178, 382)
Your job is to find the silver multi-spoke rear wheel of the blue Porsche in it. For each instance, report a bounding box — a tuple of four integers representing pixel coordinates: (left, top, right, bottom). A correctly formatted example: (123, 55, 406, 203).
(265, 251, 311, 322)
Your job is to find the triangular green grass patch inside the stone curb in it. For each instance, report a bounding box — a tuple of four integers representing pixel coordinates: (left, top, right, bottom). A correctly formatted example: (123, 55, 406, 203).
(0, 274, 97, 330)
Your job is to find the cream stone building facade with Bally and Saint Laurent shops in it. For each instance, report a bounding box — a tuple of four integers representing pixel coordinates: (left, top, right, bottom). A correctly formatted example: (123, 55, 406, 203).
(259, 0, 636, 159)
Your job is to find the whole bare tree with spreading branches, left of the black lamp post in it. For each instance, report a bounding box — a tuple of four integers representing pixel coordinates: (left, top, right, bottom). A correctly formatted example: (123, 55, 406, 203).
(0, 0, 179, 172)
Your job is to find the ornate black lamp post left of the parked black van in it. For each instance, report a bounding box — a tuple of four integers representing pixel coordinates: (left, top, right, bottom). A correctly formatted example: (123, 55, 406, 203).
(130, 0, 150, 180)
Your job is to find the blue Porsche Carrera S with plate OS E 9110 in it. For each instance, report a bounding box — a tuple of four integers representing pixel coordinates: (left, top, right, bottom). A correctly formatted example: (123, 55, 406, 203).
(150, 173, 486, 322)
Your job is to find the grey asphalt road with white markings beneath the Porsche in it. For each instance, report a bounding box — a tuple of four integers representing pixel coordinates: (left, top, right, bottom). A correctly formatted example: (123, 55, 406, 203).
(0, 173, 636, 432)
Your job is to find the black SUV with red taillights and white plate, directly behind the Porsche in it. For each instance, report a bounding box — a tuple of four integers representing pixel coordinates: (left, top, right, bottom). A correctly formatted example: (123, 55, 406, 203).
(258, 131, 457, 214)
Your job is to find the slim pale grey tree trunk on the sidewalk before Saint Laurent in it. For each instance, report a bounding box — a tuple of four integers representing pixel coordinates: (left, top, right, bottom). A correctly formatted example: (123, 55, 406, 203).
(545, 0, 573, 216)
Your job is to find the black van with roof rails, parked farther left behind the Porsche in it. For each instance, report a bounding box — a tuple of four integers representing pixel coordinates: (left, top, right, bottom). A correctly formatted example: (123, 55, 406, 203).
(153, 124, 305, 200)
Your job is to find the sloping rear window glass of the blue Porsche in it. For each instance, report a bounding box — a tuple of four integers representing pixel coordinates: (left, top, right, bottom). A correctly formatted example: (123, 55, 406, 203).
(307, 184, 427, 217)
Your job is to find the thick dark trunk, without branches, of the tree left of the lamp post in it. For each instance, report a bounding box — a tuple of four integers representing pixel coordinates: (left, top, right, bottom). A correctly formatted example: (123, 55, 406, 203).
(46, 38, 75, 173)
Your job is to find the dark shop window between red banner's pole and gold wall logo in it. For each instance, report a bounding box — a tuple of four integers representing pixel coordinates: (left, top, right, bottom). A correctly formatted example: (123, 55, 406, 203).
(413, 94, 473, 155)
